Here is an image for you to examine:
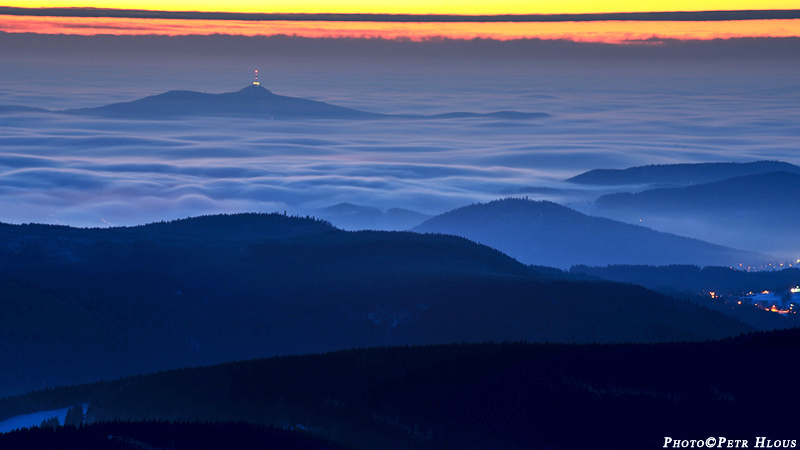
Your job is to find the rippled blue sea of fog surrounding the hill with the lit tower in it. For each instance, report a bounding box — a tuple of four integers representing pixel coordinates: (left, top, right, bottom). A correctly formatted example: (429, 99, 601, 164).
(0, 56, 800, 230)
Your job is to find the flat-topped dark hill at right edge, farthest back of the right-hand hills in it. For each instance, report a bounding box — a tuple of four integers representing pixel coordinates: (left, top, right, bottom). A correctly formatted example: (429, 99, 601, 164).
(566, 161, 800, 186)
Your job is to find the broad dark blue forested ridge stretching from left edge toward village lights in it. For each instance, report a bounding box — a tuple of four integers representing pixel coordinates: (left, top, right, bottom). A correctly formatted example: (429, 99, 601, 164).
(0, 214, 752, 394)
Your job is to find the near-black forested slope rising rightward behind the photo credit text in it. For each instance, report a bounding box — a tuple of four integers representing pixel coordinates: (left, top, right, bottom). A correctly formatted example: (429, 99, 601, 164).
(0, 329, 800, 450)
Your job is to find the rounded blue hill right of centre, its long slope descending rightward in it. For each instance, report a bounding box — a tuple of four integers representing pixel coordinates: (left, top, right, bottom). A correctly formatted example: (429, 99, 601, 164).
(413, 198, 767, 268)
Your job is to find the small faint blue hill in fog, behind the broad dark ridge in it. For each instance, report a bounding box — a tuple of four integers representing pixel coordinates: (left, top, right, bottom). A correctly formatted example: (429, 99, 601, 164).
(316, 203, 431, 230)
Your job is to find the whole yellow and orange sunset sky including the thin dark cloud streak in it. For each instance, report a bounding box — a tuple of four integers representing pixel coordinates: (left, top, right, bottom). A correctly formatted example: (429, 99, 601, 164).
(0, 4, 800, 43)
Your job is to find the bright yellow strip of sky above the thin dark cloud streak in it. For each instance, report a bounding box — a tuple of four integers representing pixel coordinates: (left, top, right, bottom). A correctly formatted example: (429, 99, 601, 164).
(3, 0, 798, 15)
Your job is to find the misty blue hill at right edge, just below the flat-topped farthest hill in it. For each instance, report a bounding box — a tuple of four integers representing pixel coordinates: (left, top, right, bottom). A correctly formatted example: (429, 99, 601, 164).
(592, 172, 800, 258)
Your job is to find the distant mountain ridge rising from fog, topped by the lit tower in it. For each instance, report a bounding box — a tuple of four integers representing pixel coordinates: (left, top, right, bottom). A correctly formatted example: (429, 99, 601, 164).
(0, 84, 550, 120)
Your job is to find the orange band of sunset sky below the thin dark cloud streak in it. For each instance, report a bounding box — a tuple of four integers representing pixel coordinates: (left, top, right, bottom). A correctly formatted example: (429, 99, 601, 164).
(0, 15, 800, 43)
